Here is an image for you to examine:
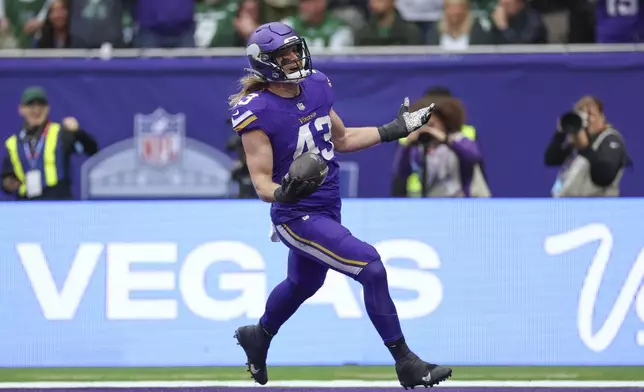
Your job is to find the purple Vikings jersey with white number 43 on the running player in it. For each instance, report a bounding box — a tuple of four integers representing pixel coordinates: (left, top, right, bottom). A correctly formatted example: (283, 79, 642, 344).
(232, 71, 341, 224)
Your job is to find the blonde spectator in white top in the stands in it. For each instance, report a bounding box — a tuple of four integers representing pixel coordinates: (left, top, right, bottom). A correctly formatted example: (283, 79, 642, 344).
(427, 0, 492, 50)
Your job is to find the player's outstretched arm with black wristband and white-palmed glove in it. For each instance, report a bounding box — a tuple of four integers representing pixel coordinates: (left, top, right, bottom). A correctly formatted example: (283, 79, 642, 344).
(330, 98, 434, 152)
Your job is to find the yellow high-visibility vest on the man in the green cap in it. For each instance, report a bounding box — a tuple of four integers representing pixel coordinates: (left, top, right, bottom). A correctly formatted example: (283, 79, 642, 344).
(4, 122, 60, 196)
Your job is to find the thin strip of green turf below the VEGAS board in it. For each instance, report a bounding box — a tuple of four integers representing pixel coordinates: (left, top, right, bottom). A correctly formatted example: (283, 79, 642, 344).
(0, 366, 644, 382)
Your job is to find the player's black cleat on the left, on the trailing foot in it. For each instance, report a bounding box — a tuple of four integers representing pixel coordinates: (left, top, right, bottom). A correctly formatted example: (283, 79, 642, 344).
(235, 324, 271, 385)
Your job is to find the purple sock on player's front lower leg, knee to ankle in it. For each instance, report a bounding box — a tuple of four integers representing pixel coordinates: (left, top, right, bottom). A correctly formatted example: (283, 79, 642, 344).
(356, 260, 403, 344)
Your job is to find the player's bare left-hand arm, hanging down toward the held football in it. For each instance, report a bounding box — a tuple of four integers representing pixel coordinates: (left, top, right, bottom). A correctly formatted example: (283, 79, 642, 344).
(241, 130, 279, 203)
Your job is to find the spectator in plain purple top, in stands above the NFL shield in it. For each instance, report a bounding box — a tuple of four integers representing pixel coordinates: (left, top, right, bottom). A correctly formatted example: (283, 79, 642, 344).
(134, 0, 195, 48)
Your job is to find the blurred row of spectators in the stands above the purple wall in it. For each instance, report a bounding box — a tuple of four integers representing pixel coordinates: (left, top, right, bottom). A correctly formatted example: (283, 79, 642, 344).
(0, 0, 644, 50)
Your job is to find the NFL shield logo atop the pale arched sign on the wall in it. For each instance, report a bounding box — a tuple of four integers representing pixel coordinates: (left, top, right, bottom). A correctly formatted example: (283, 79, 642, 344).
(134, 108, 186, 166)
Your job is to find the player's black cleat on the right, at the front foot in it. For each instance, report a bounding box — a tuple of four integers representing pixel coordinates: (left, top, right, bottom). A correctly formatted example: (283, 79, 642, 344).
(396, 352, 452, 389)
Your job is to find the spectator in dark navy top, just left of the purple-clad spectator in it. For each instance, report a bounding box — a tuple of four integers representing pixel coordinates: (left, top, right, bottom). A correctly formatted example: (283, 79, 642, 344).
(67, 0, 126, 49)
